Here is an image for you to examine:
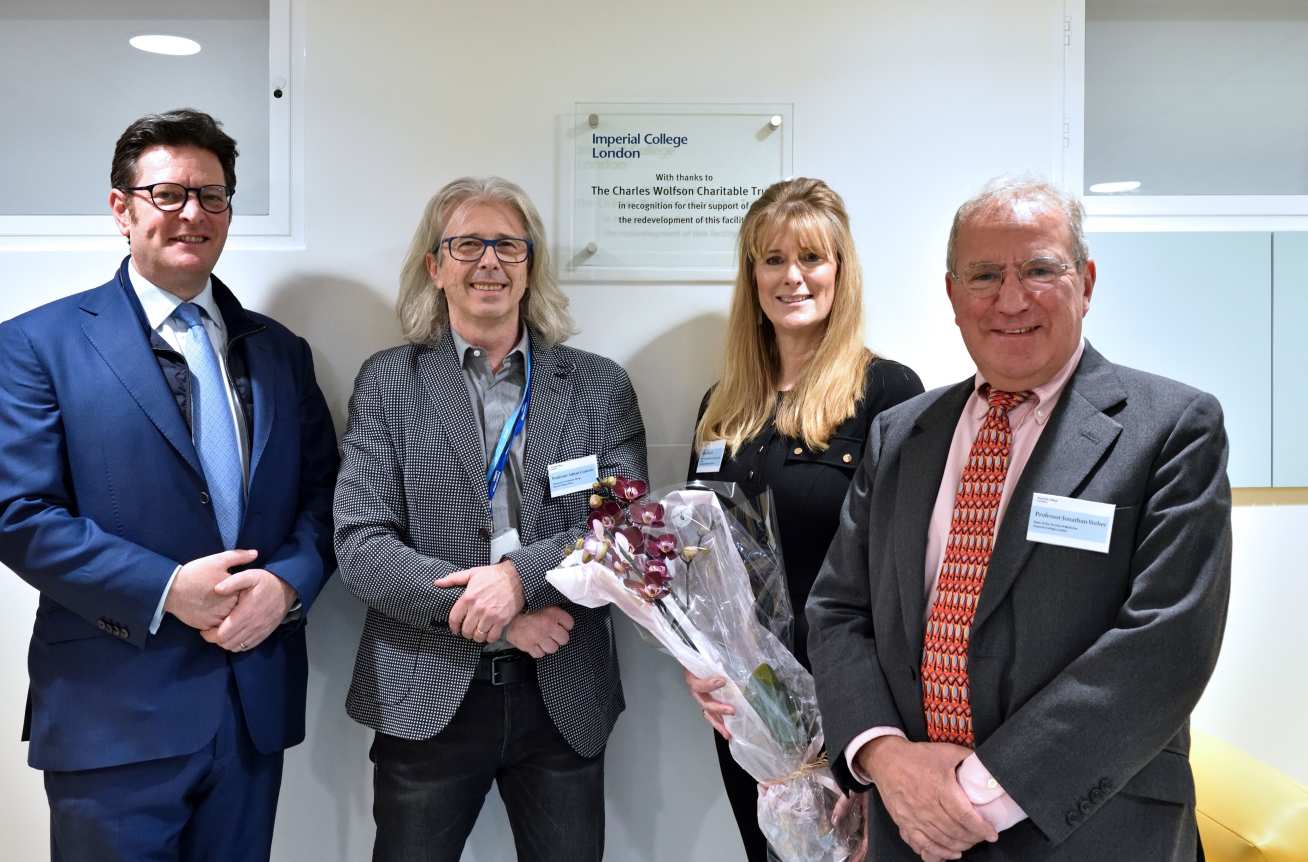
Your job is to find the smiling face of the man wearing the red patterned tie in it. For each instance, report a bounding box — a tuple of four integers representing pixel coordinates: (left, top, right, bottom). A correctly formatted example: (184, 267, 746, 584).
(944, 205, 1095, 392)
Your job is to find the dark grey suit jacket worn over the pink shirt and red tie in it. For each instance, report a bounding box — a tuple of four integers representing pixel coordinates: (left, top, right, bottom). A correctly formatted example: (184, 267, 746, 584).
(808, 344, 1231, 862)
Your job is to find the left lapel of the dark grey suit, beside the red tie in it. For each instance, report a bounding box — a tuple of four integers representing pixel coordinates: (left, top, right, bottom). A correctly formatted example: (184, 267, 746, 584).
(895, 379, 973, 649)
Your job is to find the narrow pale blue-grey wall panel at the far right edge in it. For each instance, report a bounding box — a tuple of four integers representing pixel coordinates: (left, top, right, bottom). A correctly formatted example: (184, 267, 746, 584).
(1271, 233, 1308, 488)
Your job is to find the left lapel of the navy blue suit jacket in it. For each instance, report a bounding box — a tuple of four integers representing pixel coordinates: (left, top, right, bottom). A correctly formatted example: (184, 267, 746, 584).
(81, 279, 204, 476)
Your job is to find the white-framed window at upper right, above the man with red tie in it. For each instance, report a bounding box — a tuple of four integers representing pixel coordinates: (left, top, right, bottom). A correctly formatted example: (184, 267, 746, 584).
(1063, 0, 1308, 229)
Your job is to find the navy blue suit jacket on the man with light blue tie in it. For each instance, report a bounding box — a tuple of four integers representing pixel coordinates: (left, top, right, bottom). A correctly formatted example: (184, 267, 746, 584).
(0, 260, 337, 770)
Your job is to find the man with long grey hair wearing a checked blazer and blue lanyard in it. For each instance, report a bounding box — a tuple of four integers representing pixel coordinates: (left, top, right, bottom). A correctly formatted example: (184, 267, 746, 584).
(335, 178, 646, 862)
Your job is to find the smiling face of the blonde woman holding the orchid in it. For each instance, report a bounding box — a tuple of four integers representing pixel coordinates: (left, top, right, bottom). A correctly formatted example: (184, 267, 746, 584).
(753, 228, 840, 335)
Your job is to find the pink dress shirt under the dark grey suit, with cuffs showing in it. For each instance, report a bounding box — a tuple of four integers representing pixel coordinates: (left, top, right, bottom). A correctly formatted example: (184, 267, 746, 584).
(845, 340, 1086, 832)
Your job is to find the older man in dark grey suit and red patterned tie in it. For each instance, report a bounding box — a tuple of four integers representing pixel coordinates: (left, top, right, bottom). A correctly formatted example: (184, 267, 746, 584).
(808, 182, 1231, 862)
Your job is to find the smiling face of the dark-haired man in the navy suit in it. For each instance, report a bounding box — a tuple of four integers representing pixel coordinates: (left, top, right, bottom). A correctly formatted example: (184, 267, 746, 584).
(109, 147, 232, 300)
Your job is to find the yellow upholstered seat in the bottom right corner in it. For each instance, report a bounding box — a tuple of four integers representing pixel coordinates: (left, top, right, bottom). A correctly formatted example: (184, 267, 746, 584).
(1190, 731, 1308, 862)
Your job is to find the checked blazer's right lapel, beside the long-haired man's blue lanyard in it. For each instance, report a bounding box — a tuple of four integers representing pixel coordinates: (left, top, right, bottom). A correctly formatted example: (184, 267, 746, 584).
(518, 336, 573, 543)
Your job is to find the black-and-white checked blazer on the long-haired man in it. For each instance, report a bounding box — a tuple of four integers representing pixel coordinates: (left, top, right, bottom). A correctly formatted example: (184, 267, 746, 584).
(335, 334, 646, 756)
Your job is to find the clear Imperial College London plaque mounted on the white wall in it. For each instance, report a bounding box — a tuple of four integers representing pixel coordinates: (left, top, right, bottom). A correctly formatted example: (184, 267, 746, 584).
(560, 102, 794, 281)
